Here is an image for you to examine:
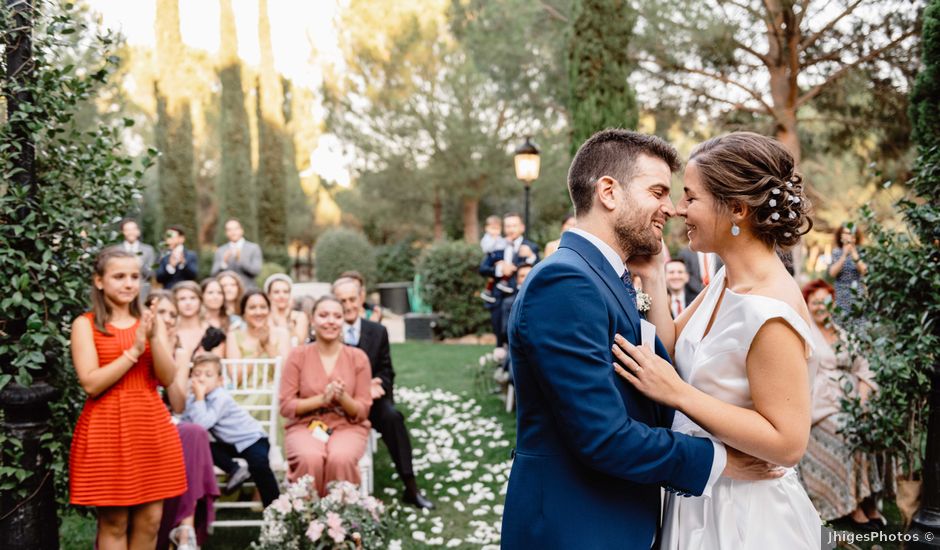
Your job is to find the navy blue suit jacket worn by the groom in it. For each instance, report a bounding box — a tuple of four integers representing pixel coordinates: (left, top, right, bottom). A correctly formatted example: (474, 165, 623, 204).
(502, 232, 714, 550)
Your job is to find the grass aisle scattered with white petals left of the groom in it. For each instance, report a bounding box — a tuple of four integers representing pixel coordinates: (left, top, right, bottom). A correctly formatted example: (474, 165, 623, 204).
(375, 343, 516, 548)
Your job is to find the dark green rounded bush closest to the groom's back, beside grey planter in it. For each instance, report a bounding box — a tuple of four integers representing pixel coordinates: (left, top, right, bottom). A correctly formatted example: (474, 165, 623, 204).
(418, 241, 490, 338)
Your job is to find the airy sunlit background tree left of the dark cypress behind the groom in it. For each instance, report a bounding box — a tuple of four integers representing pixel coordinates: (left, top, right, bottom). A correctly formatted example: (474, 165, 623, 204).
(328, 0, 562, 242)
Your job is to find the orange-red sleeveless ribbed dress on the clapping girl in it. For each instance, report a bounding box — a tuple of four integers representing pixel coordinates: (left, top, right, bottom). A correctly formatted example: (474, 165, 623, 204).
(69, 313, 186, 506)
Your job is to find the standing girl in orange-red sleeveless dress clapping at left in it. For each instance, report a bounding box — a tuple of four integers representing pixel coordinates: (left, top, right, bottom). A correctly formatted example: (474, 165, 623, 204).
(69, 249, 186, 550)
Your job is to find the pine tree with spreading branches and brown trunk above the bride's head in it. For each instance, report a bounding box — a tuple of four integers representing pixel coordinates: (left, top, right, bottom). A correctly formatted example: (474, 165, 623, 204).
(636, 0, 922, 161)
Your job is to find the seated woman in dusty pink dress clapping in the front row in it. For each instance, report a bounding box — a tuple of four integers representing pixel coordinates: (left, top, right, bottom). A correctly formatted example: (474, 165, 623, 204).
(280, 296, 372, 495)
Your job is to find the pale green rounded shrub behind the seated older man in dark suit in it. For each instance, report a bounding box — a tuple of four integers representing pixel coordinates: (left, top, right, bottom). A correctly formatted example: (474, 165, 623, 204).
(313, 228, 375, 285)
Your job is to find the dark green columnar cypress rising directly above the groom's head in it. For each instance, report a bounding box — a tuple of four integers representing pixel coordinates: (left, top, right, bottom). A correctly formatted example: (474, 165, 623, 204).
(568, 0, 639, 152)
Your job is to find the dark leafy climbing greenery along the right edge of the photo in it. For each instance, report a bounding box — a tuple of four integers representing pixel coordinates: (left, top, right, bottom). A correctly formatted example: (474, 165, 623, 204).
(844, 11, 940, 477)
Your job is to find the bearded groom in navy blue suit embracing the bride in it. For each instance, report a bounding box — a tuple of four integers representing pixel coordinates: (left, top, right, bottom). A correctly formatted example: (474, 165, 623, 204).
(502, 130, 728, 550)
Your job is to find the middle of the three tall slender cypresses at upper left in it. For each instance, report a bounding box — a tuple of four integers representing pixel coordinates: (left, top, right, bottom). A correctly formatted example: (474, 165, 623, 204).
(217, 0, 257, 240)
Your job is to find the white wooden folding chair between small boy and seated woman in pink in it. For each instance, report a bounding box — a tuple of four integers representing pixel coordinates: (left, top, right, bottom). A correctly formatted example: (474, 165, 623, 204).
(212, 357, 287, 528)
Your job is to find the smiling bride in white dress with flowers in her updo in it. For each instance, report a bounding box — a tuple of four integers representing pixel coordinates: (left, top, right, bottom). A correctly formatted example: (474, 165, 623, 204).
(614, 132, 821, 550)
